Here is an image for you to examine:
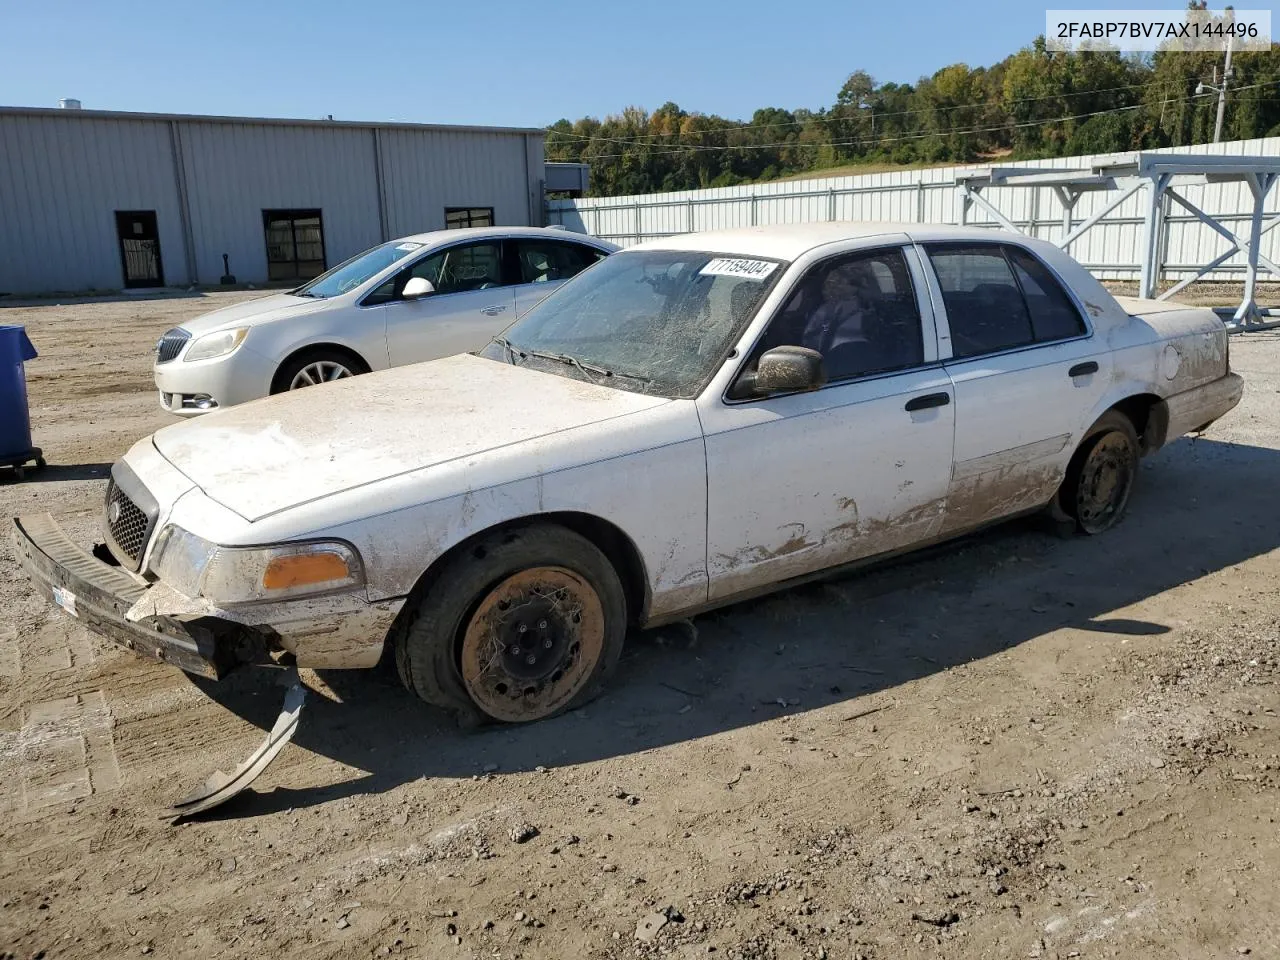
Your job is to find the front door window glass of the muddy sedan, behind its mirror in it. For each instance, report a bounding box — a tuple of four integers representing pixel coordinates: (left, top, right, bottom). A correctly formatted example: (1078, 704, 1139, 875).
(753, 247, 924, 381)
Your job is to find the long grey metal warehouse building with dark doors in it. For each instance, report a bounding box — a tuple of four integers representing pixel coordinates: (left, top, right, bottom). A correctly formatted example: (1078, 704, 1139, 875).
(0, 108, 544, 293)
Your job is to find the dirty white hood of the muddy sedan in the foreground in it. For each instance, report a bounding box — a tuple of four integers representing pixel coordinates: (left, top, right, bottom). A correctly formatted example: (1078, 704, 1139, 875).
(154, 355, 671, 522)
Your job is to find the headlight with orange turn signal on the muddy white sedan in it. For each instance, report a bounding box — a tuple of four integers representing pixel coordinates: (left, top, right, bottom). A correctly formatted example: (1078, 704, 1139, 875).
(151, 525, 365, 605)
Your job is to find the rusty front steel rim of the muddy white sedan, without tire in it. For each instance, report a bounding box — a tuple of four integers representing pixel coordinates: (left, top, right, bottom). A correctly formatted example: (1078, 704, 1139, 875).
(460, 567, 604, 723)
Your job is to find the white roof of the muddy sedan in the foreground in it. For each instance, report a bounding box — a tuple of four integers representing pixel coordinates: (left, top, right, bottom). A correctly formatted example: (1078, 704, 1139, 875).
(630, 220, 1027, 260)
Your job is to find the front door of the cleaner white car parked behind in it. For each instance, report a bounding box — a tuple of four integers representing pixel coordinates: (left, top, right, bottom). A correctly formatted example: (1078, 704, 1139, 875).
(376, 239, 516, 366)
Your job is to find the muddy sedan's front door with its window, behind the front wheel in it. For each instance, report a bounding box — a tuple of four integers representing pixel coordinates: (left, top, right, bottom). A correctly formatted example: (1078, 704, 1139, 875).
(699, 238, 955, 599)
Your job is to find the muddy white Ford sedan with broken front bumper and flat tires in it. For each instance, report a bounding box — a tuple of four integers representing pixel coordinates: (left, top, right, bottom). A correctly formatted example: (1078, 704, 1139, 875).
(14, 223, 1242, 721)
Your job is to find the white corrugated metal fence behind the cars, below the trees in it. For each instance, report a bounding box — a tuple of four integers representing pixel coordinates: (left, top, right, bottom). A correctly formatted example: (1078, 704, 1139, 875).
(548, 137, 1280, 279)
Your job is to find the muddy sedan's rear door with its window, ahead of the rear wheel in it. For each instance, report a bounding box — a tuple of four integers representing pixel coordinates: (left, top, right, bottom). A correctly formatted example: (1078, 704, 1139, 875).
(923, 242, 1111, 534)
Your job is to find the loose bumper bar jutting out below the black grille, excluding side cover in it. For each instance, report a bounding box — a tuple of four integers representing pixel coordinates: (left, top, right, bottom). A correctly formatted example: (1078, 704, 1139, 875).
(13, 513, 266, 680)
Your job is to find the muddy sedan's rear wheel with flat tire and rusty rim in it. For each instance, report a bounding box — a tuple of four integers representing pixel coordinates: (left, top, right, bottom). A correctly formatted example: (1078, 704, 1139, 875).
(1057, 410, 1142, 535)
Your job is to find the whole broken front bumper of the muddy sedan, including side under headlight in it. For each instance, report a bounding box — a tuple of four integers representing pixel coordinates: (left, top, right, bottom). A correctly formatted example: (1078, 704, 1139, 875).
(13, 513, 403, 680)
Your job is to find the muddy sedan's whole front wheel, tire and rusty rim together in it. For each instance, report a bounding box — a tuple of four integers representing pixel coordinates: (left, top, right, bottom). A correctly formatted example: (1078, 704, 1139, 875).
(392, 524, 627, 726)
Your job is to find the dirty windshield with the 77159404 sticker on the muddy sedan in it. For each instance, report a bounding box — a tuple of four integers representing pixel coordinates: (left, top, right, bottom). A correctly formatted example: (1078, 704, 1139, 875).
(483, 250, 782, 397)
